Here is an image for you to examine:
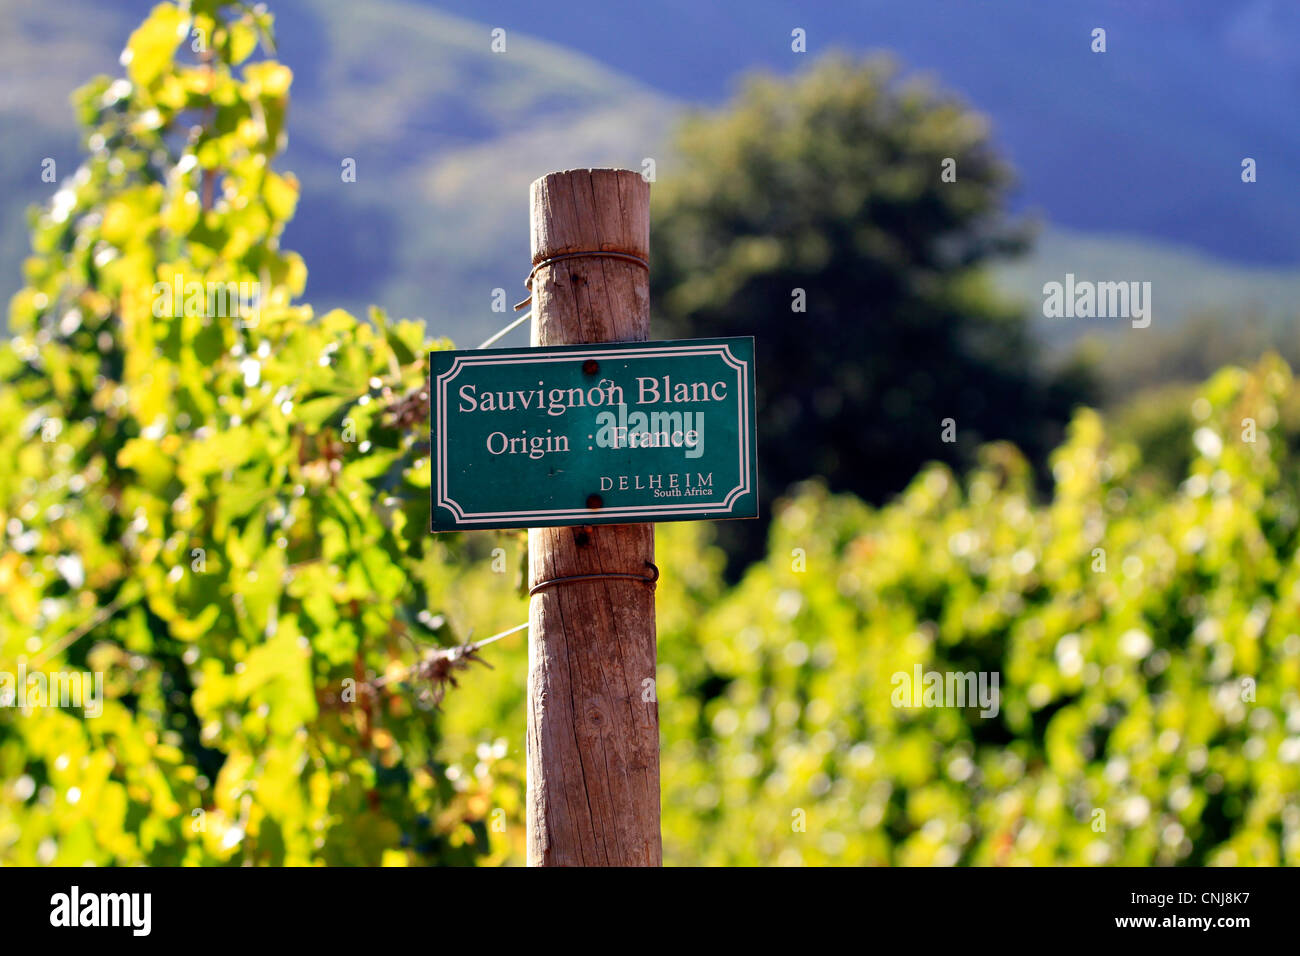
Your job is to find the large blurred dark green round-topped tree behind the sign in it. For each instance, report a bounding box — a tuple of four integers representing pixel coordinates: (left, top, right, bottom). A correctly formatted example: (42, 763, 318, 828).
(651, 56, 1091, 564)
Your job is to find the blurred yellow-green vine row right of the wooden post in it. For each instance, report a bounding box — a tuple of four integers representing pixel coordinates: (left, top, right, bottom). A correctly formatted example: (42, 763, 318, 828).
(660, 359, 1300, 865)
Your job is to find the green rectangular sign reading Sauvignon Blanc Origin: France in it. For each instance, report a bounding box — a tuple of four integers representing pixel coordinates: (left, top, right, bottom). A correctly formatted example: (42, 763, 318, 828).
(429, 337, 758, 531)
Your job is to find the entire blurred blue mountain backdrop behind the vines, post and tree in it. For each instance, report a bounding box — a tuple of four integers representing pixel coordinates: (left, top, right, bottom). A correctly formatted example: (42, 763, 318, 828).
(0, 0, 1300, 345)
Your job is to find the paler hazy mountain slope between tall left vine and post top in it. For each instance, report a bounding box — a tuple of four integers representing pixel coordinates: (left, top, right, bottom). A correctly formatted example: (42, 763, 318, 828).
(0, 0, 677, 341)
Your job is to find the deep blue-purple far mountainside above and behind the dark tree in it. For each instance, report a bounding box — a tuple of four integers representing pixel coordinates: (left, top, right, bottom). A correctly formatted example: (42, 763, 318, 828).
(423, 0, 1300, 265)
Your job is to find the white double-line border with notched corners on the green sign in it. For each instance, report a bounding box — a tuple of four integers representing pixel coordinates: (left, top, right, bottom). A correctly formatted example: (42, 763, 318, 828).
(434, 345, 750, 524)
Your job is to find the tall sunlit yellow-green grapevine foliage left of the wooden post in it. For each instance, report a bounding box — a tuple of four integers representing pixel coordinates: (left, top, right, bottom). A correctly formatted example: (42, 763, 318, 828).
(0, 0, 520, 865)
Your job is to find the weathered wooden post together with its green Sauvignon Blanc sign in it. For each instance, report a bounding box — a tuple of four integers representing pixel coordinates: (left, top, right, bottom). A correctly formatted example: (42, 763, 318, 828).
(429, 169, 758, 866)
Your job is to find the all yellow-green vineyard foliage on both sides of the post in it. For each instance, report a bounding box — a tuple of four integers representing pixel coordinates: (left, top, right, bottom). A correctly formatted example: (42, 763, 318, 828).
(0, 0, 1300, 865)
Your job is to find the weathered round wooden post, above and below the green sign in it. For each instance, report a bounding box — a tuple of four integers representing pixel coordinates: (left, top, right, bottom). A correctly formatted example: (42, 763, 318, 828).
(527, 169, 663, 866)
